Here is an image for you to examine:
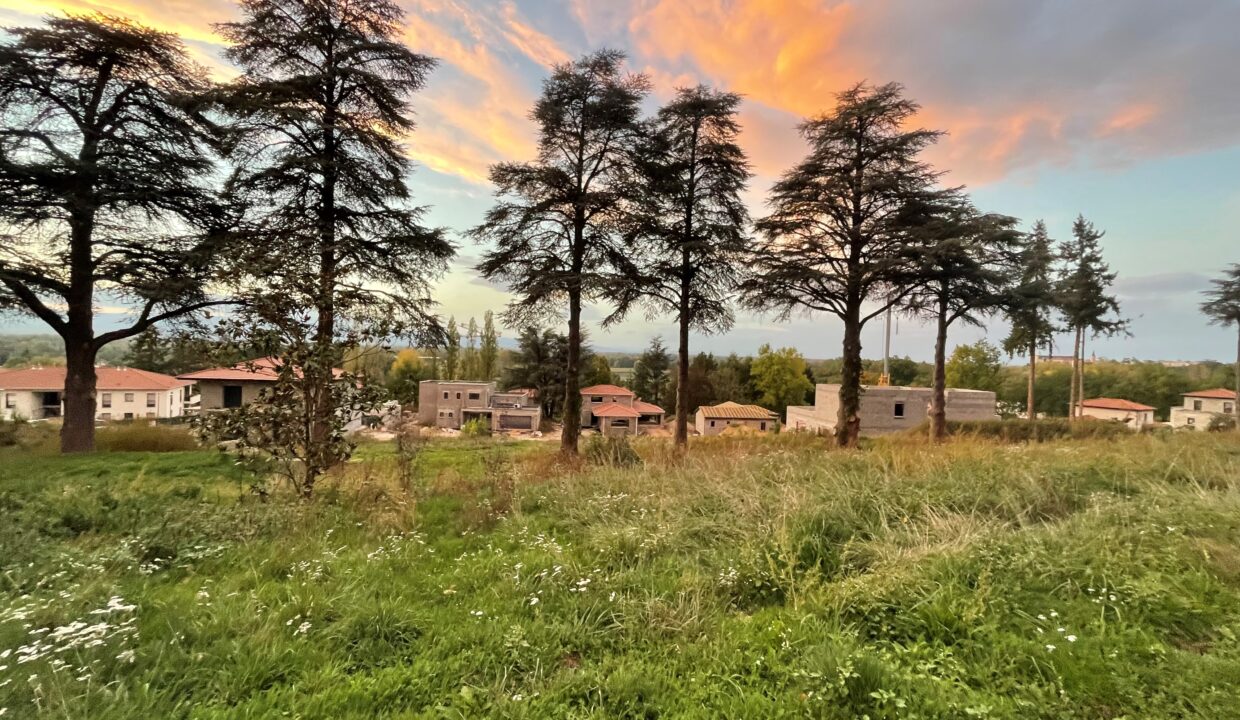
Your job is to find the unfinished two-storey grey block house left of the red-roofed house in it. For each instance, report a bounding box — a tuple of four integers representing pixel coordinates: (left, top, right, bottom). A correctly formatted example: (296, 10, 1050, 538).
(418, 380, 542, 430)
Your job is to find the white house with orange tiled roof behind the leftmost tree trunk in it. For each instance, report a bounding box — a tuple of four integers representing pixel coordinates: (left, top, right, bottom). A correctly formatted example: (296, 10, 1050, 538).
(0, 367, 190, 420)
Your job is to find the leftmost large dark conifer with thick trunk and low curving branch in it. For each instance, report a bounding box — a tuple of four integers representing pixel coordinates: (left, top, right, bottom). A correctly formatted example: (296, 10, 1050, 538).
(0, 15, 226, 452)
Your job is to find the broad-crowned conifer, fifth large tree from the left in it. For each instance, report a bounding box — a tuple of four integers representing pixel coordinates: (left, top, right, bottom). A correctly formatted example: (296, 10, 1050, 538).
(743, 83, 940, 446)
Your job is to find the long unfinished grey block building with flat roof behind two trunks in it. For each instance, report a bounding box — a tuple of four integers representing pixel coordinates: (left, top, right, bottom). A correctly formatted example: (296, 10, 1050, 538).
(786, 383, 998, 436)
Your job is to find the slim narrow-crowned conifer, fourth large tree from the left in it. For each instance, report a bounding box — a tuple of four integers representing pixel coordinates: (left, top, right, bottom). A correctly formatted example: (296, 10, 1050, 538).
(636, 86, 750, 447)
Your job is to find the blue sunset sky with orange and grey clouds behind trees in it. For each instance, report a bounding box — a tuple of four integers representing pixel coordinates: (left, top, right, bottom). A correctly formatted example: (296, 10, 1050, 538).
(0, 0, 1240, 361)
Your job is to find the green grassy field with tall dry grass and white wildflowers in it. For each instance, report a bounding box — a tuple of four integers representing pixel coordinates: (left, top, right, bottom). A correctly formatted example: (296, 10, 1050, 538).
(0, 434, 1240, 720)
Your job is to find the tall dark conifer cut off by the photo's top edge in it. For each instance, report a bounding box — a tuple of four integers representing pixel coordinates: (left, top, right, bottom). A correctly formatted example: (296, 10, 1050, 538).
(216, 0, 454, 496)
